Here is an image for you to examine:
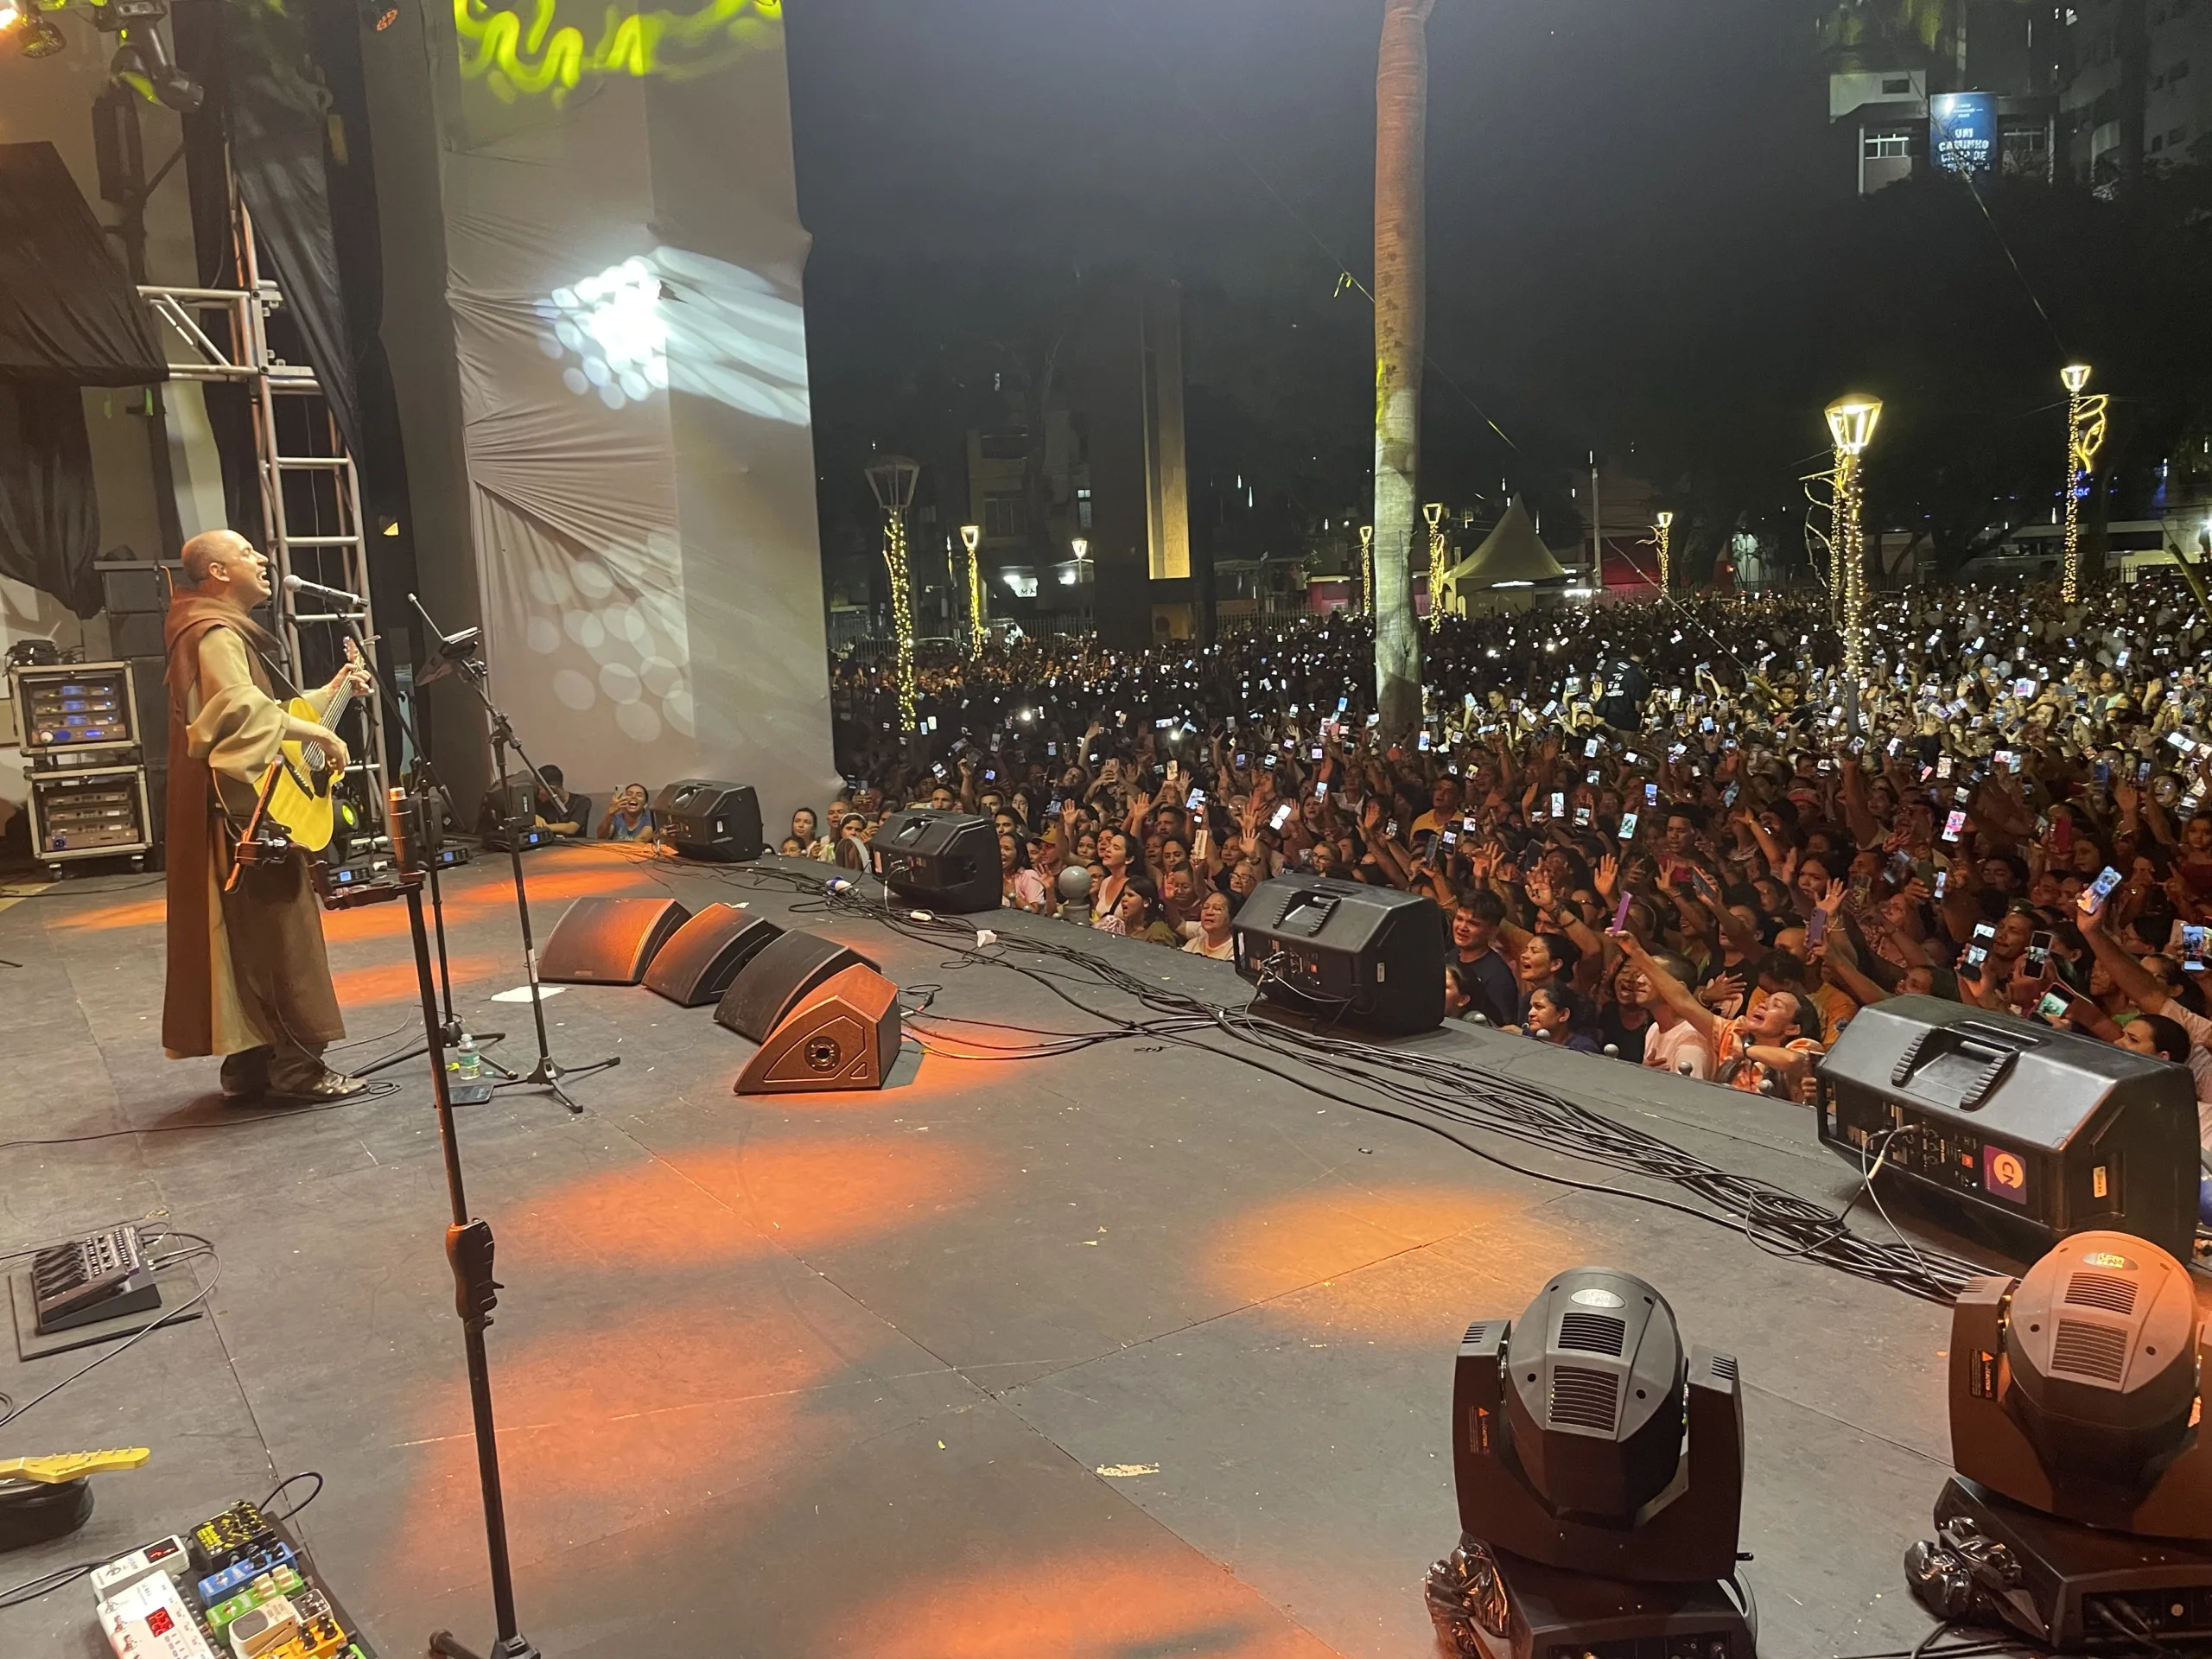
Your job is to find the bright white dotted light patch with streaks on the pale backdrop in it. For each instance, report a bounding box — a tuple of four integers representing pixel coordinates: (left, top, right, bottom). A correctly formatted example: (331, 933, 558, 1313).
(536, 248, 810, 427)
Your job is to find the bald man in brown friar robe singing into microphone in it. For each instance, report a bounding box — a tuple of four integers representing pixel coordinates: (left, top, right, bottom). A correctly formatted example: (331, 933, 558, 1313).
(162, 531, 370, 1106)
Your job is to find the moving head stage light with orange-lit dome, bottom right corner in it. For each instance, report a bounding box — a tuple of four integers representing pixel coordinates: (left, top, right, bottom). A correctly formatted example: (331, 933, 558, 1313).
(1904, 1232, 2212, 1652)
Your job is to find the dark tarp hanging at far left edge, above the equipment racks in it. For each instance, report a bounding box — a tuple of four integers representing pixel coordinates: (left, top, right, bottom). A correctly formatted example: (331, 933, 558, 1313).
(0, 143, 168, 617)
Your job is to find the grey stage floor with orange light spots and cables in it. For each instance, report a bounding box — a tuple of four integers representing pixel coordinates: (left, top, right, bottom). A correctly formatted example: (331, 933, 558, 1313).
(0, 847, 2088, 1659)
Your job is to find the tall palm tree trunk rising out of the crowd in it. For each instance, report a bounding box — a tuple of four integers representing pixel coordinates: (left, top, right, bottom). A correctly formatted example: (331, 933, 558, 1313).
(1374, 0, 1435, 739)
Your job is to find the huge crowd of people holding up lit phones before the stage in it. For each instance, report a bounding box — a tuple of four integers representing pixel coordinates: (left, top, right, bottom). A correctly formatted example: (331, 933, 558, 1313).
(814, 577, 2212, 1203)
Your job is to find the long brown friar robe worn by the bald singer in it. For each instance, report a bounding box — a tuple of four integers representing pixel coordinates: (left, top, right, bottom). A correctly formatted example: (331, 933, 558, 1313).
(162, 588, 345, 1062)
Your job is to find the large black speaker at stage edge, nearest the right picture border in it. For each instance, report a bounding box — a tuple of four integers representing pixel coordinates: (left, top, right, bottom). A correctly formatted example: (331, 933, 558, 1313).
(1818, 998, 2196, 1261)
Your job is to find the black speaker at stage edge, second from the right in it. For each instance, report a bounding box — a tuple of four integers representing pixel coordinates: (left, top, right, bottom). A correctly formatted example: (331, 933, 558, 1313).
(1232, 876, 1445, 1031)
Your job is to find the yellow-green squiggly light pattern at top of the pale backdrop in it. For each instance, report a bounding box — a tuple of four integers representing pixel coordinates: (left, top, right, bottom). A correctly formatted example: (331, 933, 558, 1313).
(454, 0, 783, 104)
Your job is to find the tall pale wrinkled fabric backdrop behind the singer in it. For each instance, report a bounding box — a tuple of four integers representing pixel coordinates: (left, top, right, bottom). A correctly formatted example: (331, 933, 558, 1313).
(422, 1, 836, 841)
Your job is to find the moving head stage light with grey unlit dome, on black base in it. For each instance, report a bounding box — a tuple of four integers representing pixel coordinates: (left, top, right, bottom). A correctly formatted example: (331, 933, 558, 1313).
(1427, 1268, 1758, 1659)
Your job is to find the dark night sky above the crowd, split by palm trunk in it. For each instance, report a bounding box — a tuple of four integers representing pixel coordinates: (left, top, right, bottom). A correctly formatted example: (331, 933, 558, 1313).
(790, 0, 1849, 499)
